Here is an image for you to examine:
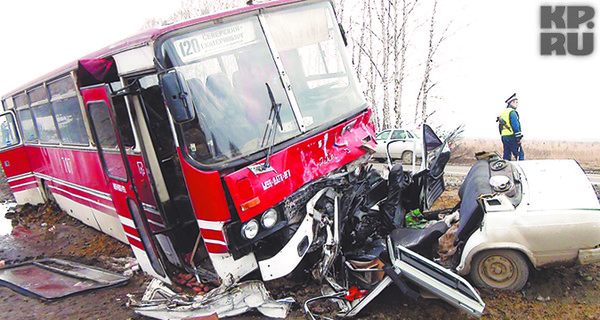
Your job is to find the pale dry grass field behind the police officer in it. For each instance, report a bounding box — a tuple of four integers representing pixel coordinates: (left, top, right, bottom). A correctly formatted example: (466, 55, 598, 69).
(451, 139, 600, 171)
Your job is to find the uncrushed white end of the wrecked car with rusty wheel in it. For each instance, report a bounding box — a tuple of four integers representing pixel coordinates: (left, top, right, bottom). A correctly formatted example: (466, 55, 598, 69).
(456, 156, 600, 290)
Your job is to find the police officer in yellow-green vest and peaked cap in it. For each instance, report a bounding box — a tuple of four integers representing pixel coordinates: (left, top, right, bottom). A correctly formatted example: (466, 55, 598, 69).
(496, 93, 525, 160)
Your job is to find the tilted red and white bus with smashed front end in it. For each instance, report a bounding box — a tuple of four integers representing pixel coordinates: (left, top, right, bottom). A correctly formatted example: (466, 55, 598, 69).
(0, 0, 486, 315)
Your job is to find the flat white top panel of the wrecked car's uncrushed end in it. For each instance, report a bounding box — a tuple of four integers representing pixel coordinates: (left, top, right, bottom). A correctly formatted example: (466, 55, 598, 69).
(513, 160, 600, 210)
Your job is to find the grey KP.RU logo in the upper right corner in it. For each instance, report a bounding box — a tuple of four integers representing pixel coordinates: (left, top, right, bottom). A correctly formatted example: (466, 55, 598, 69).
(540, 6, 595, 56)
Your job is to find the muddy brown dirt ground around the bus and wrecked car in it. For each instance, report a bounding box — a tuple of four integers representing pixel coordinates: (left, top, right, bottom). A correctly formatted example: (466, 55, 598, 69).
(0, 169, 600, 320)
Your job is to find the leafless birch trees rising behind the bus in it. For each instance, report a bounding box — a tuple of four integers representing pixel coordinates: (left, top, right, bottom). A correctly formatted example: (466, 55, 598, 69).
(144, 0, 450, 130)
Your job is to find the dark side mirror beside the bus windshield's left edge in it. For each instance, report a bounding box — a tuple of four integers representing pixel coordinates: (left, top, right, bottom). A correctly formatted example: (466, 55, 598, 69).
(160, 70, 194, 122)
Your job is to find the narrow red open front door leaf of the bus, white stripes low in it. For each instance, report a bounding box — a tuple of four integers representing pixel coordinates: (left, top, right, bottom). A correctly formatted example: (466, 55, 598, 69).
(81, 85, 171, 283)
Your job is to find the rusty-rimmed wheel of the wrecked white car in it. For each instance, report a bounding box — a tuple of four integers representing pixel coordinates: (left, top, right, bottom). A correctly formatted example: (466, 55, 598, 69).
(471, 250, 529, 290)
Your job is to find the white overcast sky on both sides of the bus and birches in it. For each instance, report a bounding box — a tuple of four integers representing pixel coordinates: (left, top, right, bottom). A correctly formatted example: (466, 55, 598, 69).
(0, 0, 600, 141)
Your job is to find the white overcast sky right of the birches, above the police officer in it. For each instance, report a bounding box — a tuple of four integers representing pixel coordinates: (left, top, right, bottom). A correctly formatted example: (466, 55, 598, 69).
(436, 0, 600, 141)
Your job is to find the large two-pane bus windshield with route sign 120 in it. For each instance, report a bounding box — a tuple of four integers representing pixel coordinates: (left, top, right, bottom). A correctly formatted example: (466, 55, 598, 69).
(160, 2, 366, 165)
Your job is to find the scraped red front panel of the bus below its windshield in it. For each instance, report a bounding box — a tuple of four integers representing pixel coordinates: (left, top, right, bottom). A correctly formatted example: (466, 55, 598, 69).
(179, 111, 374, 253)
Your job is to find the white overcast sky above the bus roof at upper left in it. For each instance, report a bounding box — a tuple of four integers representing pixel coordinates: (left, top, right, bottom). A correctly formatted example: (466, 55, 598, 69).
(0, 0, 180, 96)
